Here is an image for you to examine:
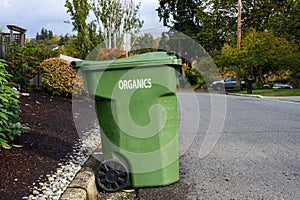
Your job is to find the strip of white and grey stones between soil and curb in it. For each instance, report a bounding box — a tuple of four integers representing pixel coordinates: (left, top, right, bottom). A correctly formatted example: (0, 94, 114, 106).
(22, 122, 101, 200)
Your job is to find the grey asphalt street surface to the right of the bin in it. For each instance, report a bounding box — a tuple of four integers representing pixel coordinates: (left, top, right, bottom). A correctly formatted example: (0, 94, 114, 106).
(178, 93, 300, 199)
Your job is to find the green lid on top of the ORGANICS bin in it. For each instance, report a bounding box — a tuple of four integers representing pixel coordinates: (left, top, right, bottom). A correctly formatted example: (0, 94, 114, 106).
(81, 52, 182, 71)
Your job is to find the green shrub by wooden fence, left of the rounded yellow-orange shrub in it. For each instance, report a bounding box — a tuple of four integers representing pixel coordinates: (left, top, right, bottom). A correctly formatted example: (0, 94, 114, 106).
(7, 42, 58, 91)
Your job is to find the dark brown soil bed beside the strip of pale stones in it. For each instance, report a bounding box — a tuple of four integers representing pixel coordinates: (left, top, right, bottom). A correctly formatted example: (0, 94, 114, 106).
(0, 92, 83, 200)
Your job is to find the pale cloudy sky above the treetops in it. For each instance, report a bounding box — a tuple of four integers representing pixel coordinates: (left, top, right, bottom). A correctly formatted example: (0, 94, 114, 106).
(0, 0, 166, 38)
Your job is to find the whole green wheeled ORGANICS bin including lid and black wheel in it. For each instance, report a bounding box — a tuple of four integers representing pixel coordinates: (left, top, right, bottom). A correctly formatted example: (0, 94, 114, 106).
(75, 52, 182, 192)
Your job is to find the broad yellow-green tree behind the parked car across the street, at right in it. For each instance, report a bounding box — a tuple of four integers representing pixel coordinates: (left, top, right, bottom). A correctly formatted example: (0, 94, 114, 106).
(217, 31, 299, 83)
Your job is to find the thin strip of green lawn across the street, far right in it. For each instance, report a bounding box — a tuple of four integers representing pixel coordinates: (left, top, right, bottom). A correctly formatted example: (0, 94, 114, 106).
(238, 89, 300, 96)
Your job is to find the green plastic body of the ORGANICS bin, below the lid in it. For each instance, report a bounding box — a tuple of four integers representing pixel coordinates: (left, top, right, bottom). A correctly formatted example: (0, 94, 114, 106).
(91, 66, 179, 187)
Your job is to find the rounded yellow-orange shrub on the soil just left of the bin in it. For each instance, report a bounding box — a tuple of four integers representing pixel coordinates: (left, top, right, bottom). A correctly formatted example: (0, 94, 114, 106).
(40, 58, 83, 96)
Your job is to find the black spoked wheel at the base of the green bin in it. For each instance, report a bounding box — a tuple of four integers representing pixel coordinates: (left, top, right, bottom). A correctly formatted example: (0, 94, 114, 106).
(95, 159, 129, 192)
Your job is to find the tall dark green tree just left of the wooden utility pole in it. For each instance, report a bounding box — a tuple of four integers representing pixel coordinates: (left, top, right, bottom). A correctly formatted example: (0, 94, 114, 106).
(157, 0, 236, 51)
